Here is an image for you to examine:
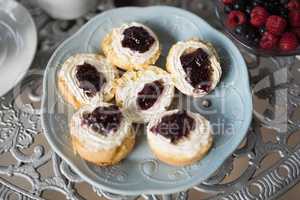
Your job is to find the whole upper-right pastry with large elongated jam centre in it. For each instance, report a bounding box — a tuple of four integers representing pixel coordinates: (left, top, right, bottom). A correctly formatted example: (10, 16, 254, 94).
(167, 40, 222, 97)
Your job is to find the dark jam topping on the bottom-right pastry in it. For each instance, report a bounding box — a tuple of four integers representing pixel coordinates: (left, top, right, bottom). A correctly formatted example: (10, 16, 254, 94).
(150, 111, 195, 143)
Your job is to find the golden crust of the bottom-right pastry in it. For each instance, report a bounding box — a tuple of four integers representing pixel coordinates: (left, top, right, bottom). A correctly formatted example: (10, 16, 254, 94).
(148, 135, 213, 166)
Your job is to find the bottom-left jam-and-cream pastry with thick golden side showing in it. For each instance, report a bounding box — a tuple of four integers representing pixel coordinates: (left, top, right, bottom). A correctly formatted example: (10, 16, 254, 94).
(70, 103, 135, 166)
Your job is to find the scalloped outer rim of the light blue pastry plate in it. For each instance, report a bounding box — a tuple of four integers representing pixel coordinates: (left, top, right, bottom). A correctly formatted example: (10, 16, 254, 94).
(41, 6, 253, 195)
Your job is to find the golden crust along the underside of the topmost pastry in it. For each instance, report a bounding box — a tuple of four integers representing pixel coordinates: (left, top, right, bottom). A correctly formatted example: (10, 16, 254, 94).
(101, 33, 161, 70)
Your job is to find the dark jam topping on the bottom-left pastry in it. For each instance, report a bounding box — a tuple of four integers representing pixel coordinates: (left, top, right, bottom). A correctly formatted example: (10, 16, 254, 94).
(81, 105, 123, 135)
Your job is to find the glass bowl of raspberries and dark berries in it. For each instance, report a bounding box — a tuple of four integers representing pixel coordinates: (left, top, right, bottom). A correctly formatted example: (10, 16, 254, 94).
(216, 0, 300, 56)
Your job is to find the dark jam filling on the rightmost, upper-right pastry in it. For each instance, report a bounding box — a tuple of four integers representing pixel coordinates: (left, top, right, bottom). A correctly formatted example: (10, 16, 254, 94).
(180, 48, 213, 92)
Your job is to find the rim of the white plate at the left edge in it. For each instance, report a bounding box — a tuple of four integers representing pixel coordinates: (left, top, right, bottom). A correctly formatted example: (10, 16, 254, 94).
(0, 1, 38, 97)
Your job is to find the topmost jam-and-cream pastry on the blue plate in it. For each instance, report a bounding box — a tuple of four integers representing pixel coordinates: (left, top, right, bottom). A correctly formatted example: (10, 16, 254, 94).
(102, 22, 161, 70)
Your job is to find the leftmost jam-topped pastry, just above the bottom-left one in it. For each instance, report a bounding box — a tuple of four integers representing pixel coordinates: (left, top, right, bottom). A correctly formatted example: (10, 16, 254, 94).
(58, 54, 117, 108)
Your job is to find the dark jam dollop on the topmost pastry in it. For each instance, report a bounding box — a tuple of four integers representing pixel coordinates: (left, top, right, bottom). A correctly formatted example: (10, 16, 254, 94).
(122, 26, 155, 53)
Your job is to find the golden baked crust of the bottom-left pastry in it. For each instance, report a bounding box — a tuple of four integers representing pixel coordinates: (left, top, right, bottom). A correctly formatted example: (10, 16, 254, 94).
(71, 128, 135, 166)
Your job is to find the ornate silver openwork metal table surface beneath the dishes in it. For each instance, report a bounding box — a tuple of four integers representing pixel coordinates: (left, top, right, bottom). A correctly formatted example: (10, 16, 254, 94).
(0, 0, 300, 200)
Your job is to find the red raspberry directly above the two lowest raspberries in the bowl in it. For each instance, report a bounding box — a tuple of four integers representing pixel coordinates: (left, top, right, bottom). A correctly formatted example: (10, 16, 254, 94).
(266, 15, 287, 35)
